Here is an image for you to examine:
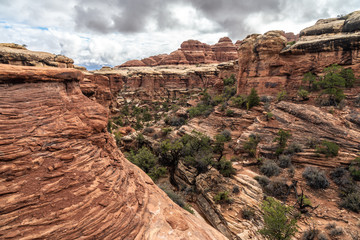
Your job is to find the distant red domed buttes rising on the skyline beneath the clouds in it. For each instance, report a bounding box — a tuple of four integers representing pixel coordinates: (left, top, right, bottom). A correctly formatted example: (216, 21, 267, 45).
(115, 37, 238, 69)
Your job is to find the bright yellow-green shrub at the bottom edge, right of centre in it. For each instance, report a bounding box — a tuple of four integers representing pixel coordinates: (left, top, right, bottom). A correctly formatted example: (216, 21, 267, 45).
(259, 197, 298, 240)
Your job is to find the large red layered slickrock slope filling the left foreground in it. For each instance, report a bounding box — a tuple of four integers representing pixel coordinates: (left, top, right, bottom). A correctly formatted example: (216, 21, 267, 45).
(0, 65, 226, 239)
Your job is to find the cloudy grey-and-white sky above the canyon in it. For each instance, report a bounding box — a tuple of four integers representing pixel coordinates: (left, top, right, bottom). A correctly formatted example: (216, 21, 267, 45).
(0, 0, 360, 69)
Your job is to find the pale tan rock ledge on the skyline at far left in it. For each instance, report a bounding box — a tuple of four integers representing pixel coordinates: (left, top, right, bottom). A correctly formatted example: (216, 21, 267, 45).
(0, 43, 74, 68)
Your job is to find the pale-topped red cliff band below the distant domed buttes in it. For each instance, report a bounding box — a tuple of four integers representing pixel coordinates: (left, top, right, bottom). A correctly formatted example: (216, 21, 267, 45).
(94, 62, 237, 100)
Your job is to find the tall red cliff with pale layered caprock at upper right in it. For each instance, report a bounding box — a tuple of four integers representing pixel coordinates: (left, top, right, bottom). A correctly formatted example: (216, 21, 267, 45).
(238, 11, 360, 94)
